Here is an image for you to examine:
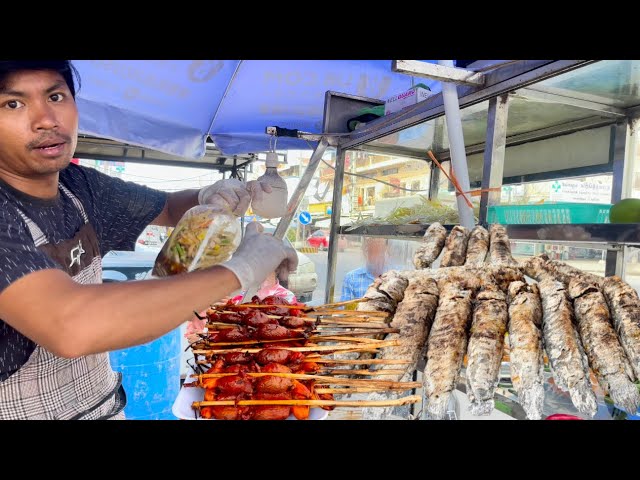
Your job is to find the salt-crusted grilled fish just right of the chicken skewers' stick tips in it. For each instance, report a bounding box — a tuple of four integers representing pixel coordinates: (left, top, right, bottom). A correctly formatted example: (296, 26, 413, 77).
(424, 283, 472, 419)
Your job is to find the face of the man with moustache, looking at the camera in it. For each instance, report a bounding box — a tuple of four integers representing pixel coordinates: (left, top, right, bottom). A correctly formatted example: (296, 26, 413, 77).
(0, 70, 78, 177)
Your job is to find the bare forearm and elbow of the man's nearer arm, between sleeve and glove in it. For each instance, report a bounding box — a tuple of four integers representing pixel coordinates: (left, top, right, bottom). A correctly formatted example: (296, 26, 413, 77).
(0, 267, 240, 358)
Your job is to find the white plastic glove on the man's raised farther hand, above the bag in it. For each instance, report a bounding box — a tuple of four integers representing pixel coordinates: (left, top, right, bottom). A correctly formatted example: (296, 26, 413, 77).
(198, 178, 271, 217)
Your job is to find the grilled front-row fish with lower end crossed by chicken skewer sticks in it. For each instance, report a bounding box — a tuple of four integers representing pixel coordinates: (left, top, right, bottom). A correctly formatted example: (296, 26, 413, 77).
(362, 277, 438, 420)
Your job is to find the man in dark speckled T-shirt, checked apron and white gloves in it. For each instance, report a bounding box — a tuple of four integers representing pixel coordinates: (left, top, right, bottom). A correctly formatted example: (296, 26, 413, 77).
(0, 60, 297, 419)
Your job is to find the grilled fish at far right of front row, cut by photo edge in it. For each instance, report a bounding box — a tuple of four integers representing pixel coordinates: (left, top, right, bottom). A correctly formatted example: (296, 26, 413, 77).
(604, 275, 640, 380)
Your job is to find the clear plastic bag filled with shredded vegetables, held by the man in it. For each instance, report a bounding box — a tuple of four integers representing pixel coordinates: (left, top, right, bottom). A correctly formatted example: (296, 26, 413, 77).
(153, 205, 242, 277)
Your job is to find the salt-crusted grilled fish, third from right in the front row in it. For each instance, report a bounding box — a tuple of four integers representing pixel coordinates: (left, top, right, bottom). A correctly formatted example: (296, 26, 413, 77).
(538, 276, 598, 417)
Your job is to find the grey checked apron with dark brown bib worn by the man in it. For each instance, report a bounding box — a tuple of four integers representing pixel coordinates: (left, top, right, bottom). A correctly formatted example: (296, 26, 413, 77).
(0, 184, 126, 420)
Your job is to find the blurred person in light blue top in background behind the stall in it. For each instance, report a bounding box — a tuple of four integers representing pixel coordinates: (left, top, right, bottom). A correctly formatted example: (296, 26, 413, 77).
(340, 237, 389, 302)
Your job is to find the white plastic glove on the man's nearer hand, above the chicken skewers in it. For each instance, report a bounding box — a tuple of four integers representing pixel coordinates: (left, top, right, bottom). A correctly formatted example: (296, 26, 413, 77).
(220, 222, 298, 290)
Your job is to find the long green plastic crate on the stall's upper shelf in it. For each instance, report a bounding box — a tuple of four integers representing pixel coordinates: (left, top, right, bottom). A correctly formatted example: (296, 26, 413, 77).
(487, 203, 611, 225)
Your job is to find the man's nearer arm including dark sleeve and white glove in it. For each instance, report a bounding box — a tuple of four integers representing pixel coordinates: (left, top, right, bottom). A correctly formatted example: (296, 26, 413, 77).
(0, 221, 298, 358)
